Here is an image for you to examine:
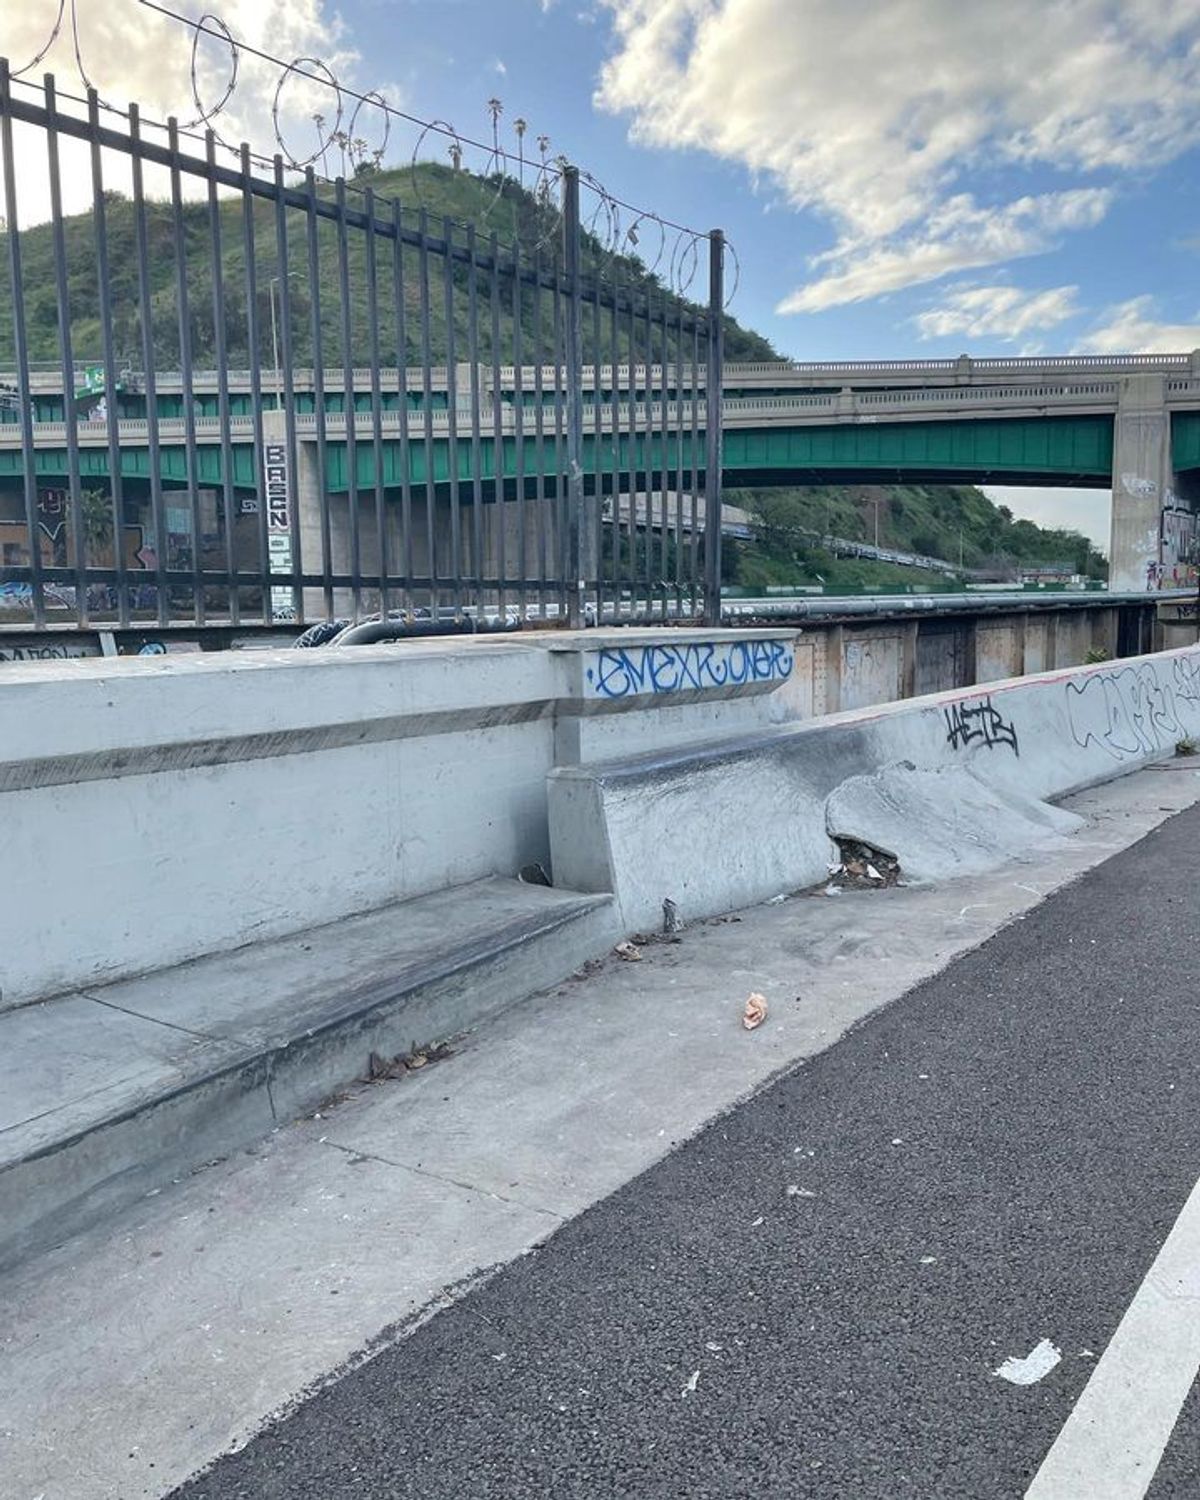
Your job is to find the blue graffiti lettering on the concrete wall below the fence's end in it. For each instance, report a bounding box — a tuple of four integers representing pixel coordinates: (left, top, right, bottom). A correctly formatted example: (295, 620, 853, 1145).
(584, 641, 794, 699)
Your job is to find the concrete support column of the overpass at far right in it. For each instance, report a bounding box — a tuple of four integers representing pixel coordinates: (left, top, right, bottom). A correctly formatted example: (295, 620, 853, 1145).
(1109, 375, 1172, 593)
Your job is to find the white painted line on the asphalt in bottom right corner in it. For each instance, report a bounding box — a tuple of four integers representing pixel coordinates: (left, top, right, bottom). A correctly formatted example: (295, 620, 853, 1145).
(1025, 1182, 1200, 1500)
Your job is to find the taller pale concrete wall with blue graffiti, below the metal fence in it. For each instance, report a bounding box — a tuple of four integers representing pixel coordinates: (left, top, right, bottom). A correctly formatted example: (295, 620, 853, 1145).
(0, 630, 794, 1007)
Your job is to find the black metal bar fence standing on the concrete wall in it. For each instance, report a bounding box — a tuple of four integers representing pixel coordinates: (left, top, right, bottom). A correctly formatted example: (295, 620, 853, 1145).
(0, 60, 723, 627)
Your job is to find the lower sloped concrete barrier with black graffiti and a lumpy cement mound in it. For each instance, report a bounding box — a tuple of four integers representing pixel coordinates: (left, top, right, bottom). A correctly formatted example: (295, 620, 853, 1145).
(549, 647, 1200, 932)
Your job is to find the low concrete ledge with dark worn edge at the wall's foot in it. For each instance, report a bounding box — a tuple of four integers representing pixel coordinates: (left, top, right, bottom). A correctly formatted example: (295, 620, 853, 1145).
(0, 879, 617, 1265)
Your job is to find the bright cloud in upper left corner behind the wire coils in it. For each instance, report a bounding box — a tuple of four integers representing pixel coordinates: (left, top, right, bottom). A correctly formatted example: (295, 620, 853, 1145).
(3, 0, 367, 224)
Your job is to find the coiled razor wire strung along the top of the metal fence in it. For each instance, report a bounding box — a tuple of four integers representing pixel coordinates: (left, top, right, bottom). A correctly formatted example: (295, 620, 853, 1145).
(11, 0, 741, 308)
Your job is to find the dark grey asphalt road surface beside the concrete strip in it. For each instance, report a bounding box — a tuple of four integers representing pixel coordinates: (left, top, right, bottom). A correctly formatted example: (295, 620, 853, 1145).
(168, 809, 1200, 1500)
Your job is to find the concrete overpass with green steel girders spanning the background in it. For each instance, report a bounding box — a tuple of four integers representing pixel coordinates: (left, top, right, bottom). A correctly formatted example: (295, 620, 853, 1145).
(0, 351, 1200, 590)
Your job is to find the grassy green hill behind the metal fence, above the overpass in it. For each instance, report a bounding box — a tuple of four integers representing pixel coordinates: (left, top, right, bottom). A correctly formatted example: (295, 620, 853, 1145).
(0, 162, 779, 368)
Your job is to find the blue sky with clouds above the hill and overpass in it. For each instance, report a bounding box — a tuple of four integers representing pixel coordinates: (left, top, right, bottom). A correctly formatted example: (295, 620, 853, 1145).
(11, 0, 1200, 542)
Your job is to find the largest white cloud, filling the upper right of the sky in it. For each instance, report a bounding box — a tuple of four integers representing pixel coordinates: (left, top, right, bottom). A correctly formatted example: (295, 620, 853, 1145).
(596, 0, 1200, 312)
